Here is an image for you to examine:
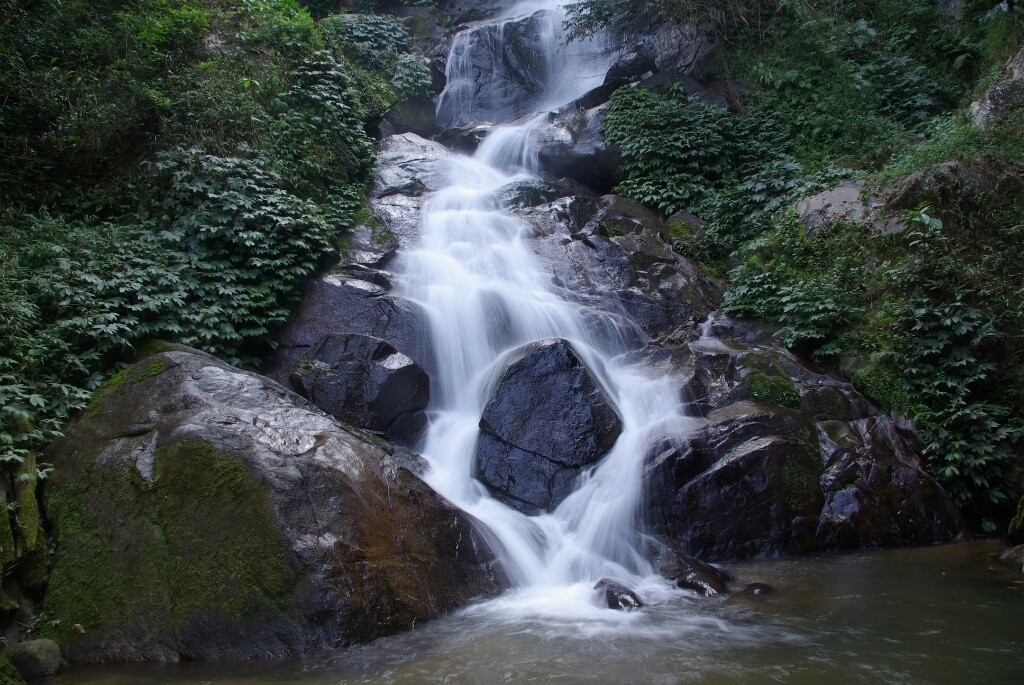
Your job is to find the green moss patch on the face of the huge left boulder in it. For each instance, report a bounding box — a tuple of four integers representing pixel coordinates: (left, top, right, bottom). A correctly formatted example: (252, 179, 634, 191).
(44, 440, 297, 643)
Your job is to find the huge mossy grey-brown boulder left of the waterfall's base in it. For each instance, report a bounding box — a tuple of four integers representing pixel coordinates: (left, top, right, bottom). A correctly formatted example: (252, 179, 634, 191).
(44, 348, 504, 662)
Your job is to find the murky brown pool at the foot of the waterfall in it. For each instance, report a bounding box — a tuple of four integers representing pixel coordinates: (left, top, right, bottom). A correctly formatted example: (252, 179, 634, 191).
(52, 542, 1024, 685)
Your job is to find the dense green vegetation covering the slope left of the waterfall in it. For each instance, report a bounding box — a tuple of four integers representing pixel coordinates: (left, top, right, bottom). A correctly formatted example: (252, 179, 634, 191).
(0, 0, 429, 609)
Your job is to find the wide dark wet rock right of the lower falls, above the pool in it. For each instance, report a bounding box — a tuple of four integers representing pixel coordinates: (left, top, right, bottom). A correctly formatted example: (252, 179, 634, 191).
(644, 339, 966, 560)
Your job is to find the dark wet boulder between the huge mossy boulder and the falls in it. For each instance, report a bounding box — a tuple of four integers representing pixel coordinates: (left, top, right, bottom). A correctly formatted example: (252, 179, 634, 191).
(289, 334, 430, 444)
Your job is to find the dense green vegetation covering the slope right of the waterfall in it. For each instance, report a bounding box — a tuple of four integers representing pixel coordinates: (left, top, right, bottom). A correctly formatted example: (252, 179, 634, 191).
(585, 0, 1024, 528)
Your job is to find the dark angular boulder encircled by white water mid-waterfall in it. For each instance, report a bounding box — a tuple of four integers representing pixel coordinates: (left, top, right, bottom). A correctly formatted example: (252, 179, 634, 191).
(476, 340, 622, 513)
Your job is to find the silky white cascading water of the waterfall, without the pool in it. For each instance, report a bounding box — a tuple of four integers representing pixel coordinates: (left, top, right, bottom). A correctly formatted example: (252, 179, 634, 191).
(400, 0, 694, 620)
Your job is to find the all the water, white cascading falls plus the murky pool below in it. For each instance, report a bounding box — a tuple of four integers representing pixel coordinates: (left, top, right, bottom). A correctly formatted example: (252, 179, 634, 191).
(54, 0, 1024, 685)
